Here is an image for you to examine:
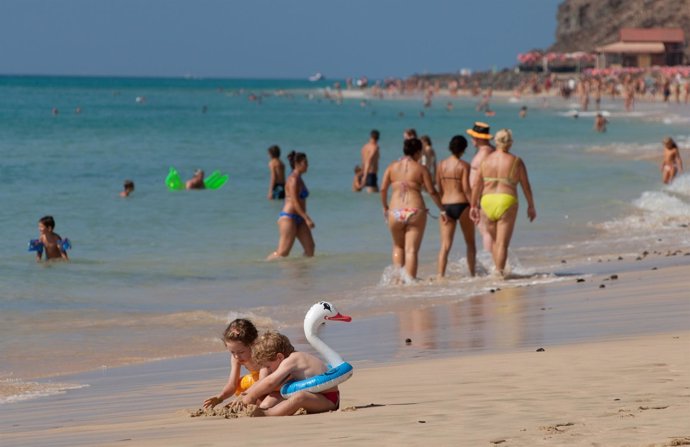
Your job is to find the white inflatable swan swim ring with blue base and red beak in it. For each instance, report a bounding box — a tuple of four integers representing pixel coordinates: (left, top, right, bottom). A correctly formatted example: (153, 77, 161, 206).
(280, 301, 352, 399)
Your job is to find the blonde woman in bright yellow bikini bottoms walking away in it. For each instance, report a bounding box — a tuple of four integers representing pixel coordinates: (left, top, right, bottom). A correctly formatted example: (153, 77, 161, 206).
(470, 129, 537, 276)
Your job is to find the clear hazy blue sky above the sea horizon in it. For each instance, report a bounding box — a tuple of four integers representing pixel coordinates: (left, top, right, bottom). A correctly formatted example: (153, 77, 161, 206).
(0, 0, 562, 79)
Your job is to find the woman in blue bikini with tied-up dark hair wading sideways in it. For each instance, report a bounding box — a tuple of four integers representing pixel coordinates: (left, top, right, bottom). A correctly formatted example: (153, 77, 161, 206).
(267, 151, 316, 260)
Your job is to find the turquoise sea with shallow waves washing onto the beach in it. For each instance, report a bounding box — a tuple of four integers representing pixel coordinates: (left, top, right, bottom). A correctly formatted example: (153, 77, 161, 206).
(0, 77, 690, 402)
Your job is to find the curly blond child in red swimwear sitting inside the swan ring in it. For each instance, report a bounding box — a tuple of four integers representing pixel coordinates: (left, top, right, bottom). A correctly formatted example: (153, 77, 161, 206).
(238, 331, 340, 416)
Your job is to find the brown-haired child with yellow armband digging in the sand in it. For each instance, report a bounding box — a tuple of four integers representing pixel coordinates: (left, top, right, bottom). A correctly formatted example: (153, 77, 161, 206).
(204, 318, 266, 408)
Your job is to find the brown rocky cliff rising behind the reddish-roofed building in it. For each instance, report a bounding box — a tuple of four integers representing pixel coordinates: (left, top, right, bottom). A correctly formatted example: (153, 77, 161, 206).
(550, 0, 690, 64)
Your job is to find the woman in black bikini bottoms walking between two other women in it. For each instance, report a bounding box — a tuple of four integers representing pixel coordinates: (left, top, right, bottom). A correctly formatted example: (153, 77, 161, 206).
(436, 135, 477, 278)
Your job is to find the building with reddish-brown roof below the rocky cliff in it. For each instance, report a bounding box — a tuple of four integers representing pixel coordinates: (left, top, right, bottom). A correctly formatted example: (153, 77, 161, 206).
(596, 28, 685, 68)
